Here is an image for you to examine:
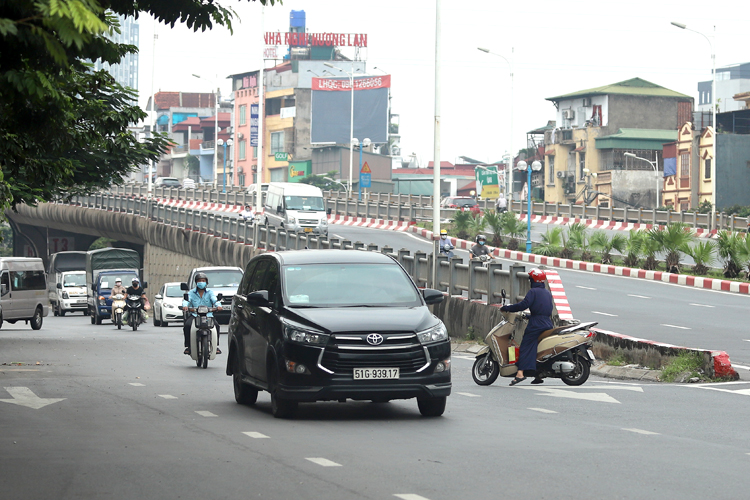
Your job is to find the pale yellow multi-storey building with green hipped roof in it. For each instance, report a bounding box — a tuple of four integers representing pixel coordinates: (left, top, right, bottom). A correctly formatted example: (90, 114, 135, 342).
(532, 78, 693, 208)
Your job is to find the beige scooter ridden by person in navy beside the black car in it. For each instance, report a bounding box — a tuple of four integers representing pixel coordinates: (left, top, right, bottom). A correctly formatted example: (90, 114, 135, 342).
(471, 290, 598, 386)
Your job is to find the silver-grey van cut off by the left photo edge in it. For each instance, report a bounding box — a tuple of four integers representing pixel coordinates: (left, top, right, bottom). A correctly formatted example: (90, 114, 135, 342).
(0, 257, 49, 330)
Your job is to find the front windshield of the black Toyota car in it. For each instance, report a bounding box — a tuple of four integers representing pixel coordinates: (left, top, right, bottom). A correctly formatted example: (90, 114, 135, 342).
(284, 264, 422, 307)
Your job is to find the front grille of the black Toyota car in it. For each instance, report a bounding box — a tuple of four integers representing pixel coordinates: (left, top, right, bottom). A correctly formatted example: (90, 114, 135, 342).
(321, 332, 427, 374)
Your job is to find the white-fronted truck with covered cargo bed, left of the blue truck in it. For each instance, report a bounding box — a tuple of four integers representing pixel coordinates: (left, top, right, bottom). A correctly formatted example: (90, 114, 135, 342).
(47, 252, 88, 316)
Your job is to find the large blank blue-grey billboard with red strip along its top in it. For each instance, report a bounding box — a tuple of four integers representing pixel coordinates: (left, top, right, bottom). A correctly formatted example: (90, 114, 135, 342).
(310, 75, 391, 144)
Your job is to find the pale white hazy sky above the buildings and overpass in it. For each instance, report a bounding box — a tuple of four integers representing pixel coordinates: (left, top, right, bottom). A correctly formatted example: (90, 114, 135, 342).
(139, 0, 750, 164)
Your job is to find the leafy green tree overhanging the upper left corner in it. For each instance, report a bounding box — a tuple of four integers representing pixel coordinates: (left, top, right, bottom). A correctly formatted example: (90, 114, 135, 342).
(0, 0, 274, 208)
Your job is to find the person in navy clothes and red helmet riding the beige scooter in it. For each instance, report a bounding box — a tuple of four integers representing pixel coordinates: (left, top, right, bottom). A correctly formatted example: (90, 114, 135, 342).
(500, 268, 554, 385)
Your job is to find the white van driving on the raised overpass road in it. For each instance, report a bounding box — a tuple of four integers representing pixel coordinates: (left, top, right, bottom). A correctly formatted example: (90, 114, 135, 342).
(263, 182, 328, 236)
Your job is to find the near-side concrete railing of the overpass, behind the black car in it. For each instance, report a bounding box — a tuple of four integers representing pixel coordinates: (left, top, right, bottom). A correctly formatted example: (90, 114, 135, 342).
(66, 193, 529, 304)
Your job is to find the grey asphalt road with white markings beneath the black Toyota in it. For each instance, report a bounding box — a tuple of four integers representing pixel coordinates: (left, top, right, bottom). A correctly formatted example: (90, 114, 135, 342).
(0, 315, 750, 500)
